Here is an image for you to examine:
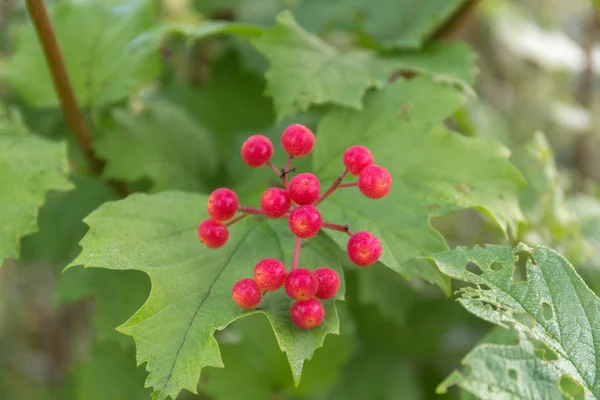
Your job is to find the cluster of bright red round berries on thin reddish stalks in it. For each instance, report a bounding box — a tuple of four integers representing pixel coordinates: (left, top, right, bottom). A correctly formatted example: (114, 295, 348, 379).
(198, 124, 392, 329)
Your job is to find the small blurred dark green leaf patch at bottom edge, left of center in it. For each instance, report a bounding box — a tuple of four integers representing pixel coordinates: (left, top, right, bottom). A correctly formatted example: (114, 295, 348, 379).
(71, 342, 150, 400)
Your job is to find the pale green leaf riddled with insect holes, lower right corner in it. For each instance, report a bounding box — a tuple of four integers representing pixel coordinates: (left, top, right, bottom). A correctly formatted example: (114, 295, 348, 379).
(434, 245, 600, 399)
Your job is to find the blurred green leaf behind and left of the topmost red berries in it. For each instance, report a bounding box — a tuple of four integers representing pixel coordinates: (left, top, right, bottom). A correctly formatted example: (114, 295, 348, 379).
(95, 98, 218, 192)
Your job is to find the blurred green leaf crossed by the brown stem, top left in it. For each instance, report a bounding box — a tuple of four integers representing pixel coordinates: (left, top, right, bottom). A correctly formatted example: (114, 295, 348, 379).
(2, 0, 160, 107)
